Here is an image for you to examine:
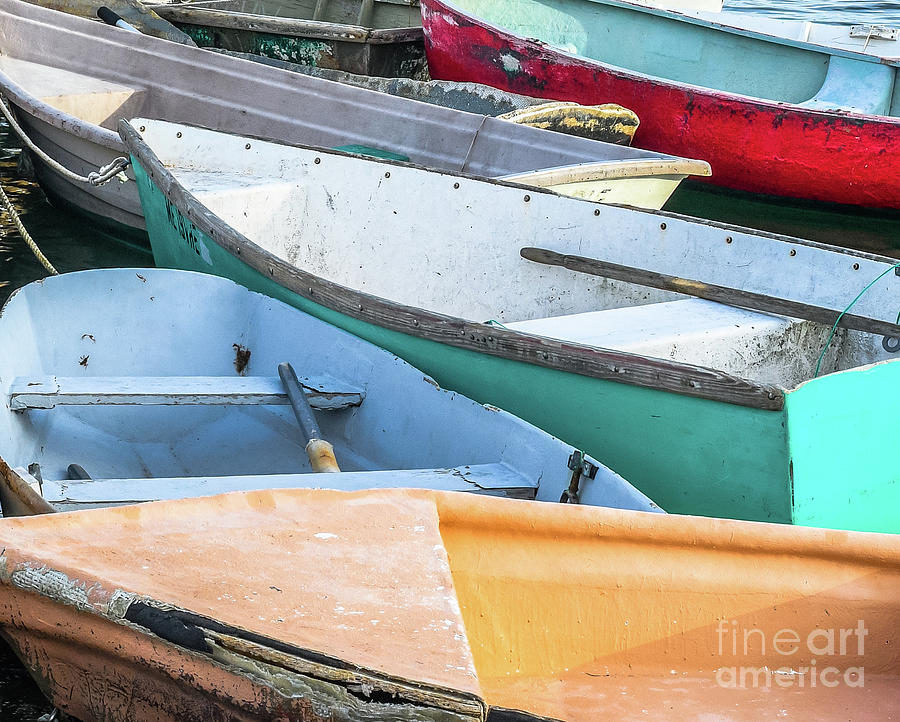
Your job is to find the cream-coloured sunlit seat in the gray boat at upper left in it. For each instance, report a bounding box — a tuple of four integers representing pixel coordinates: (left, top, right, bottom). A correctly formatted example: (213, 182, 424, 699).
(0, 56, 146, 125)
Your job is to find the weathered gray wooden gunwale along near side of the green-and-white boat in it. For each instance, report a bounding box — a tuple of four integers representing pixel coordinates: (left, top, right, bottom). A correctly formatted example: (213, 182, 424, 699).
(119, 120, 784, 411)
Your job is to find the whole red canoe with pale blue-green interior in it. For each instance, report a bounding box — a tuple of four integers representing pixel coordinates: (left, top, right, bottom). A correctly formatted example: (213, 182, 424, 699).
(421, 0, 900, 209)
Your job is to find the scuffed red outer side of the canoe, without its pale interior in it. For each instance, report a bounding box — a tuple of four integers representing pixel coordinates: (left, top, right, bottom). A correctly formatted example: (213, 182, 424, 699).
(421, 0, 900, 209)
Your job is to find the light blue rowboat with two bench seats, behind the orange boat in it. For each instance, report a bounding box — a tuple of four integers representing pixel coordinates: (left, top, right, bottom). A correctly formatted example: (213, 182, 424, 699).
(0, 269, 658, 514)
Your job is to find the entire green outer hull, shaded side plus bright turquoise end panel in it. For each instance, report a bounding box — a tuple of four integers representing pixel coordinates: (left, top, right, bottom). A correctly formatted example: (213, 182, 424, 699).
(133, 158, 900, 533)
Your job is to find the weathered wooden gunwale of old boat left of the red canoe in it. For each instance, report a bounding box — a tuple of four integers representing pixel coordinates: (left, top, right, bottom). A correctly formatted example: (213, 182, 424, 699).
(148, 4, 423, 44)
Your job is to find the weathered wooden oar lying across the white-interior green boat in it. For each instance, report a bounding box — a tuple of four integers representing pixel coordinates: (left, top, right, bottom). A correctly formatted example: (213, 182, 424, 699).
(519, 247, 900, 337)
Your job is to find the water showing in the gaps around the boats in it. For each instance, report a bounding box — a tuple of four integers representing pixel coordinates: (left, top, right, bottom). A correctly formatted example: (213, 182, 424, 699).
(0, 0, 900, 722)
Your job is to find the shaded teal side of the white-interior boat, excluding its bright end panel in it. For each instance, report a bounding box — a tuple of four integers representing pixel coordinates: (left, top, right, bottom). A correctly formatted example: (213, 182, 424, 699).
(134, 162, 791, 523)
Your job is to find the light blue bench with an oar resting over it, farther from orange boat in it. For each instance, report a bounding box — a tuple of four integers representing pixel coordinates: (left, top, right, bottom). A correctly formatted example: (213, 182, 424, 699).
(9, 376, 365, 411)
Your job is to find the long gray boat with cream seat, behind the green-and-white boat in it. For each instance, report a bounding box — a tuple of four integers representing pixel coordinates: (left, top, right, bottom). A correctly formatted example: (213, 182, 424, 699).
(0, 0, 692, 235)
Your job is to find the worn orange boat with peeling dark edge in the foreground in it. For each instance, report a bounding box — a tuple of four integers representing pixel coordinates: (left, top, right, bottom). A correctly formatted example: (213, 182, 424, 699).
(0, 490, 900, 720)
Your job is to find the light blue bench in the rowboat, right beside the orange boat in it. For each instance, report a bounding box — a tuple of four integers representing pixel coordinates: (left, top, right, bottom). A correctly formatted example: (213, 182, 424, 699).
(14, 463, 537, 509)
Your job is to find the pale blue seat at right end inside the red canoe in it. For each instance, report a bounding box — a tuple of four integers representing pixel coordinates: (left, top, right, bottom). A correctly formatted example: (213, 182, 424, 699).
(799, 55, 896, 115)
